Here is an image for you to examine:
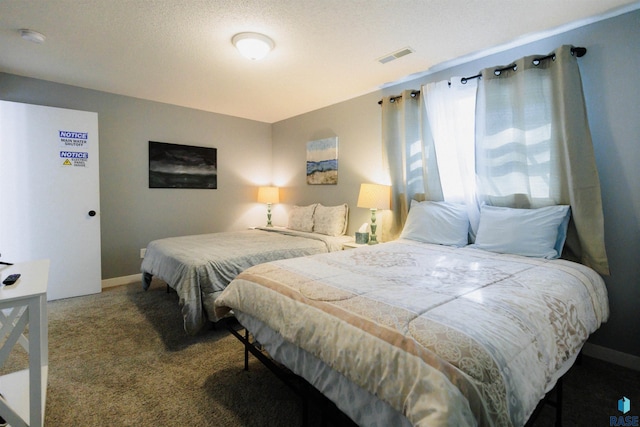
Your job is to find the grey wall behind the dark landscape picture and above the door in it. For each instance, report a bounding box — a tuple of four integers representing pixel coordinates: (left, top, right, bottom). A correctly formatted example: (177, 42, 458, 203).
(0, 73, 272, 279)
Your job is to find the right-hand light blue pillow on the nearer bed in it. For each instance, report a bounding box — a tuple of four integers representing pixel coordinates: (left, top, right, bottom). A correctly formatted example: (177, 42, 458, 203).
(473, 205, 570, 259)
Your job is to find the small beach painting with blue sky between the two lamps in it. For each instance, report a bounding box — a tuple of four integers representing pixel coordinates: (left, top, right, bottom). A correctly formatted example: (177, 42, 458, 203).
(307, 137, 338, 184)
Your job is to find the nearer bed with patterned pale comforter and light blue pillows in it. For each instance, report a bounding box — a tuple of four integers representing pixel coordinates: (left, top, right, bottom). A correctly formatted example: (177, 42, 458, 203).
(215, 205, 609, 426)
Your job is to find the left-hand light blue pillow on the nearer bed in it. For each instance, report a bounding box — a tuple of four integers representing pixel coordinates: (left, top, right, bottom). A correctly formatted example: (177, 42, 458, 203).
(400, 200, 469, 247)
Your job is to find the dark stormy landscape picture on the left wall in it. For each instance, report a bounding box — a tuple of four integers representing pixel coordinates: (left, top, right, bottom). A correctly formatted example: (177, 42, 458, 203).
(149, 141, 218, 189)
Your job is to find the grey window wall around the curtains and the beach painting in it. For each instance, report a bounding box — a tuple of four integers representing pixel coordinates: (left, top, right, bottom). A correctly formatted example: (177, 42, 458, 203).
(273, 11, 640, 356)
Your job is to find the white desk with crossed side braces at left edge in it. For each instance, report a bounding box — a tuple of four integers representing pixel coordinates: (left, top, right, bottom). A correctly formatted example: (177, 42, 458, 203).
(0, 260, 49, 427)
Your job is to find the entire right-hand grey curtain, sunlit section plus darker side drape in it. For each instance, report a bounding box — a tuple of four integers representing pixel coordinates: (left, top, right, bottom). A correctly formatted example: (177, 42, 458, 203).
(476, 46, 609, 274)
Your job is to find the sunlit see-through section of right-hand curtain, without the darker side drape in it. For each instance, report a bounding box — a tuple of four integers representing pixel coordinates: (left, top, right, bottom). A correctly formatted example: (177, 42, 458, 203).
(476, 57, 563, 208)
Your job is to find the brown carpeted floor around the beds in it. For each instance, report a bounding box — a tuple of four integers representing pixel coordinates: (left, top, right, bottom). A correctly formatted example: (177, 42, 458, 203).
(0, 281, 640, 427)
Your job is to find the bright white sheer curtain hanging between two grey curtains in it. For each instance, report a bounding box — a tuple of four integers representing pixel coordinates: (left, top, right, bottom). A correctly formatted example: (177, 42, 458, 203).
(422, 77, 479, 235)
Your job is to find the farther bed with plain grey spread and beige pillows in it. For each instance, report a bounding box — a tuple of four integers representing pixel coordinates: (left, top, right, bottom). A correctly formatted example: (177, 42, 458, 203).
(141, 204, 352, 335)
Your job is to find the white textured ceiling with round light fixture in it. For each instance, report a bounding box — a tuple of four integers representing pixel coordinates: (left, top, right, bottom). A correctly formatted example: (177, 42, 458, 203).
(0, 0, 640, 123)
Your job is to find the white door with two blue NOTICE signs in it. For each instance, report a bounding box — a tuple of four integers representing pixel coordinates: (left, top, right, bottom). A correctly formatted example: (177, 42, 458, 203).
(0, 101, 102, 300)
